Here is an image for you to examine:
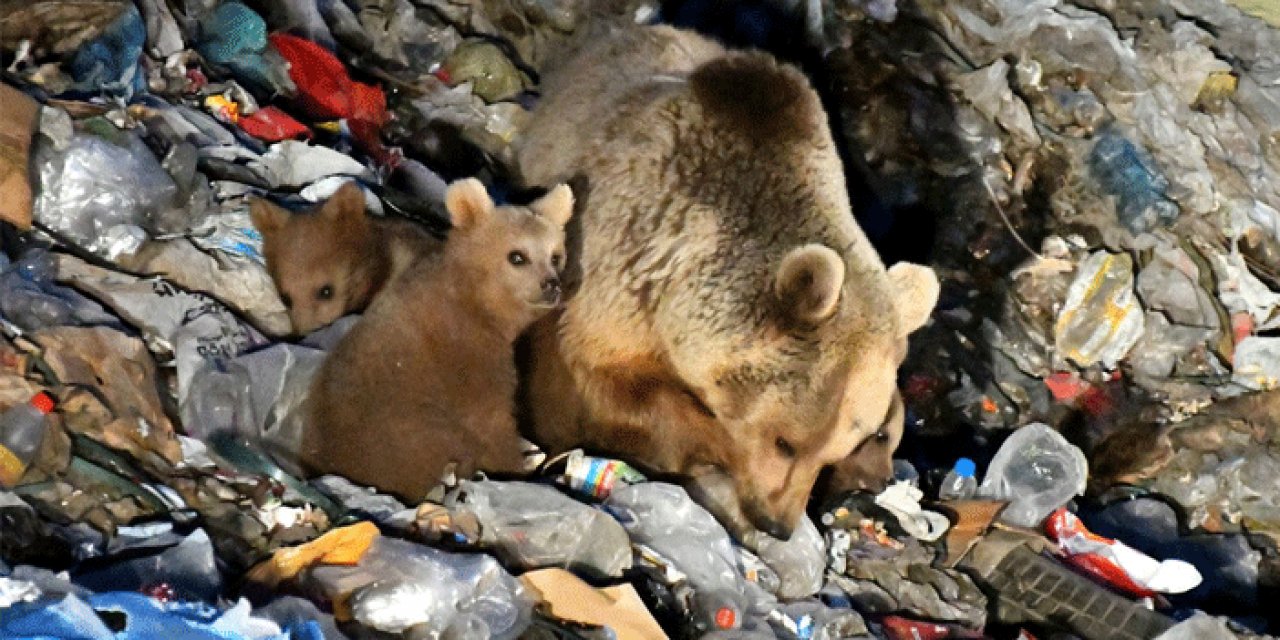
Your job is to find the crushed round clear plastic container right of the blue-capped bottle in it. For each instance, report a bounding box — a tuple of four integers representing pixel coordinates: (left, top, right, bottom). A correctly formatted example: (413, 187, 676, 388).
(978, 422, 1089, 527)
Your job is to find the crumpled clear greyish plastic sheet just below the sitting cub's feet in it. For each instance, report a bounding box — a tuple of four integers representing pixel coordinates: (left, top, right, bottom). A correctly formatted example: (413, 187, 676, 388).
(445, 481, 631, 577)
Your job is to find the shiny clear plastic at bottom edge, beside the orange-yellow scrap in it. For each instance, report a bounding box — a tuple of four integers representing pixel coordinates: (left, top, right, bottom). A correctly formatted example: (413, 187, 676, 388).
(307, 536, 532, 640)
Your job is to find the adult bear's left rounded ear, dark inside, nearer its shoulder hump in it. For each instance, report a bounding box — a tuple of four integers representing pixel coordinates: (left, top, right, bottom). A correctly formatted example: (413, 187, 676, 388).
(773, 244, 845, 325)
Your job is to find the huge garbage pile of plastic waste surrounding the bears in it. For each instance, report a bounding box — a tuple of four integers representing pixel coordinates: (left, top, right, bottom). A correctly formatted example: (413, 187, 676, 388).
(0, 0, 1280, 640)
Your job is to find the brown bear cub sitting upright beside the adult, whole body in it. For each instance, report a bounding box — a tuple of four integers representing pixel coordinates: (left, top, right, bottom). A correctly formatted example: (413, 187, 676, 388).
(302, 178, 573, 502)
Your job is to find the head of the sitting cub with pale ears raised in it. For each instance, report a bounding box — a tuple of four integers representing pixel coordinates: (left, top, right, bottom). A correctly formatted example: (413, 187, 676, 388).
(444, 178, 573, 333)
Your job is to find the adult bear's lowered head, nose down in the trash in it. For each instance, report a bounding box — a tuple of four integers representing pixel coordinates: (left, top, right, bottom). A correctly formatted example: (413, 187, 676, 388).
(677, 244, 938, 539)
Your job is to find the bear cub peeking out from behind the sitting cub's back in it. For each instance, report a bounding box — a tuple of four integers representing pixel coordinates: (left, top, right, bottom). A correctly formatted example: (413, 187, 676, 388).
(250, 182, 442, 335)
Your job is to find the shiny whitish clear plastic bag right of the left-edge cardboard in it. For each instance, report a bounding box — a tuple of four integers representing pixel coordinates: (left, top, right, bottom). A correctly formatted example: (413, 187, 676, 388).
(36, 134, 178, 257)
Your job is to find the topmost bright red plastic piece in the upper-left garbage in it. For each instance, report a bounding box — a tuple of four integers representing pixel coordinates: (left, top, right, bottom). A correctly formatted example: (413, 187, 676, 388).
(269, 33, 355, 120)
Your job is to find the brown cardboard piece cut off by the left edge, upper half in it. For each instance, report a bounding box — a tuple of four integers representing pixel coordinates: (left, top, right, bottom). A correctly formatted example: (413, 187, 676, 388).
(0, 83, 40, 230)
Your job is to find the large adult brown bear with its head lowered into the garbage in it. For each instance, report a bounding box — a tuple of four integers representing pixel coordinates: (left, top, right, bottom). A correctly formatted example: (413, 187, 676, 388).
(517, 27, 938, 538)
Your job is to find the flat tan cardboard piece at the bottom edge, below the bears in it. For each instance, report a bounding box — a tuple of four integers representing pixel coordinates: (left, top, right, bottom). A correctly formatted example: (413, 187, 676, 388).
(520, 568, 667, 640)
